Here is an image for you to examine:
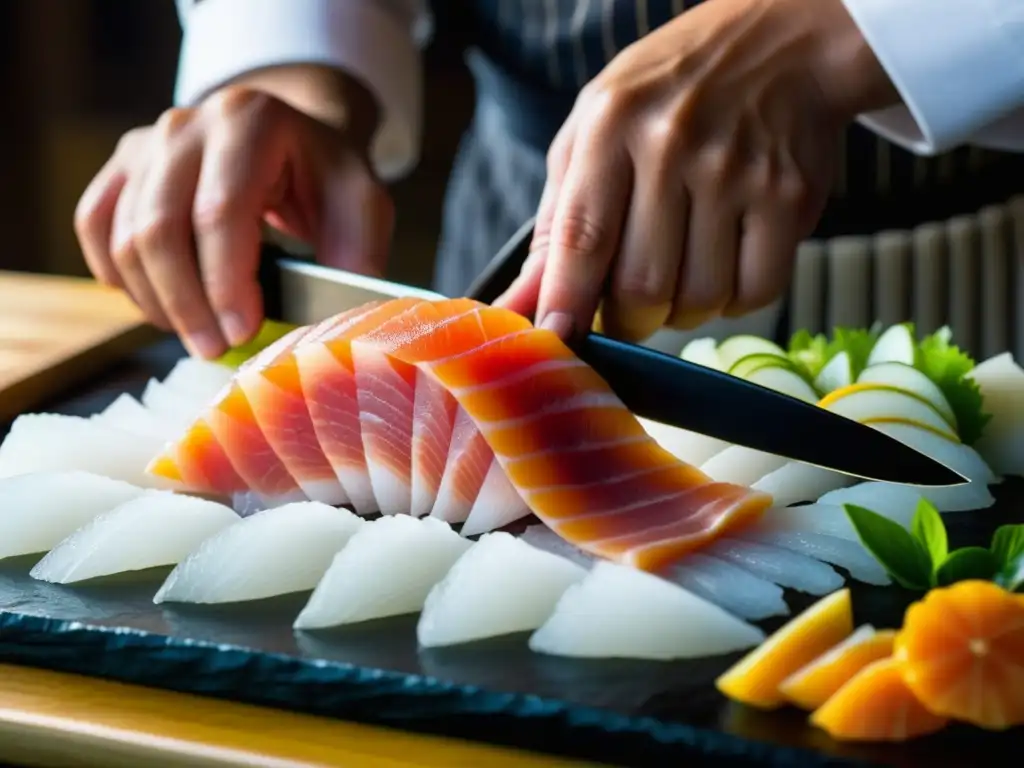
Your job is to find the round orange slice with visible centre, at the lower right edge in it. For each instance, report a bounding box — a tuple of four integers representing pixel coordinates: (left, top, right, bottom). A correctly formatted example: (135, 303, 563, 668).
(895, 581, 1024, 730)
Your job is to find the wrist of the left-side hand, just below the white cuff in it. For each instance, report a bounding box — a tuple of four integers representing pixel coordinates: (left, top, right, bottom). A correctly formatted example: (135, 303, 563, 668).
(224, 65, 380, 147)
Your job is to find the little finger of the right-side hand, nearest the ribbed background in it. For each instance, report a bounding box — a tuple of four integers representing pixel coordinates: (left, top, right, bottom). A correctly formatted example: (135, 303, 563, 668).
(722, 204, 802, 317)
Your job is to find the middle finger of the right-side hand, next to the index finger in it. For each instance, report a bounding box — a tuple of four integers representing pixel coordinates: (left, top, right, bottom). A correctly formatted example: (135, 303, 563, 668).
(601, 154, 688, 341)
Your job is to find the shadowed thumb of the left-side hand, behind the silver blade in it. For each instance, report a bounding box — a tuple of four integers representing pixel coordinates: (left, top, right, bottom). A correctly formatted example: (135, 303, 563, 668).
(314, 158, 394, 276)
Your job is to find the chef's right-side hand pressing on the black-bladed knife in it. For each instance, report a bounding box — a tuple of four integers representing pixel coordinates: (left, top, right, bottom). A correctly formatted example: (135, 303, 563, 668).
(500, 0, 897, 340)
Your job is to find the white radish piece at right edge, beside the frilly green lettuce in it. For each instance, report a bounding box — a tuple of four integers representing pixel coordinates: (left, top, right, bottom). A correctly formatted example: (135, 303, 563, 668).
(968, 352, 1024, 476)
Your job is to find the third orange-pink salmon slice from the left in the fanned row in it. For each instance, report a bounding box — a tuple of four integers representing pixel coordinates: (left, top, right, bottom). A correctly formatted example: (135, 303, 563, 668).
(236, 328, 348, 505)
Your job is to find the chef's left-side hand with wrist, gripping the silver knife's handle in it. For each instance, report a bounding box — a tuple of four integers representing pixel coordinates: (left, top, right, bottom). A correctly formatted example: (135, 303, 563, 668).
(75, 64, 394, 357)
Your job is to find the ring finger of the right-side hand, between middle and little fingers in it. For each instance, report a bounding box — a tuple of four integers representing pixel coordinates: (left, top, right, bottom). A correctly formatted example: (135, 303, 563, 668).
(668, 187, 741, 329)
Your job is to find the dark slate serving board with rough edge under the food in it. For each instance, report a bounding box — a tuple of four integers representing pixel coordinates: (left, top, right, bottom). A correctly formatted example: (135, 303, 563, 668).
(0, 343, 1024, 767)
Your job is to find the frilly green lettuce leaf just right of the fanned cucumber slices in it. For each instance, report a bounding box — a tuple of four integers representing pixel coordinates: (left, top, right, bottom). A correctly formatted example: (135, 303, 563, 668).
(918, 328, 992, 445)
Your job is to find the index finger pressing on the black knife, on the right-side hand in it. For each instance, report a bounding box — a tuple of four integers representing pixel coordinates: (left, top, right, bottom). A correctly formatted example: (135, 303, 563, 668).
(537, 130, 633, 338)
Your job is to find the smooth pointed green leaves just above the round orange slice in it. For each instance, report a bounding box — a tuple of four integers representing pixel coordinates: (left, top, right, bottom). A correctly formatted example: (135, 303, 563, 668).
(843, 499, 1024, 592)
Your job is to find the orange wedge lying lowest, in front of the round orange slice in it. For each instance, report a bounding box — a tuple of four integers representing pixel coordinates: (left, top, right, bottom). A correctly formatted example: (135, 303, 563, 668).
(811, 657, 949, 741)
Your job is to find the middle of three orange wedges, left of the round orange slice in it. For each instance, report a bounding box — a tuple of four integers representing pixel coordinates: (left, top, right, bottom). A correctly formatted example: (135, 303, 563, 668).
(778, 624, 896, 711)
